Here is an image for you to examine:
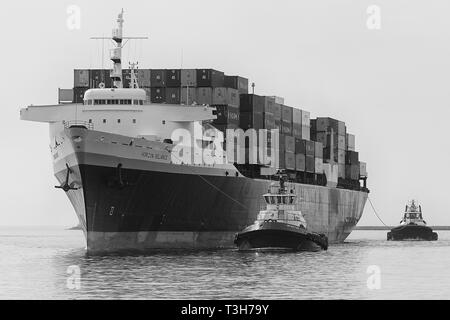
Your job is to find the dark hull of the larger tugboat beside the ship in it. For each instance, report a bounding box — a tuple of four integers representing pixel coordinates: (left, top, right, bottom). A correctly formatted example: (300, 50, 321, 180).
(234, 222, 328, 251)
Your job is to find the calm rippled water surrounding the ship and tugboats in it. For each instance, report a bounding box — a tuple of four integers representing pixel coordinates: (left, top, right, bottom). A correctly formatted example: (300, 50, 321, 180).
(0, 228, 450, 299)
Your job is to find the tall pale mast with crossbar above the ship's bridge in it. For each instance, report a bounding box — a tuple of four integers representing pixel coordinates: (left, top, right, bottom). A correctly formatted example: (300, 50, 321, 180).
(91, 9, 148, 88)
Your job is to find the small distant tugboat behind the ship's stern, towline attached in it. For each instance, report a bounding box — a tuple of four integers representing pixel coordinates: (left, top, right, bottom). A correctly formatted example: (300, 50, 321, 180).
(387, 200, 438, 241)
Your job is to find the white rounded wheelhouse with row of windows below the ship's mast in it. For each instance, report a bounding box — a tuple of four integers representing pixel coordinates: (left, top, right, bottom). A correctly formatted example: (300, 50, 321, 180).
(84, 88, 146, 105)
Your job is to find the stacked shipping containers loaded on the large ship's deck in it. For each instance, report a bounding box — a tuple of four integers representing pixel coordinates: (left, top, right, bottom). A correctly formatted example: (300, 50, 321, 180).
(73, 69, 367, 188)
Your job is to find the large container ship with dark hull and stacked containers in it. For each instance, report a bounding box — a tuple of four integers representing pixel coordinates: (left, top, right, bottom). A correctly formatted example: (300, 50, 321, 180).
(20, 11, 369, 252)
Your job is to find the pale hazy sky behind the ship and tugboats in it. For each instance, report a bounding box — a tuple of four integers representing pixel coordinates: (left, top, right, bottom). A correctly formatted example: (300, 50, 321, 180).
(0, 0, 450, 225)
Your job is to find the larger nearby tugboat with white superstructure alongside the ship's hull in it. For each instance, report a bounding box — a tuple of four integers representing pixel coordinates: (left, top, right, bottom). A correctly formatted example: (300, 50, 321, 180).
(234, 175, 328, 251)
